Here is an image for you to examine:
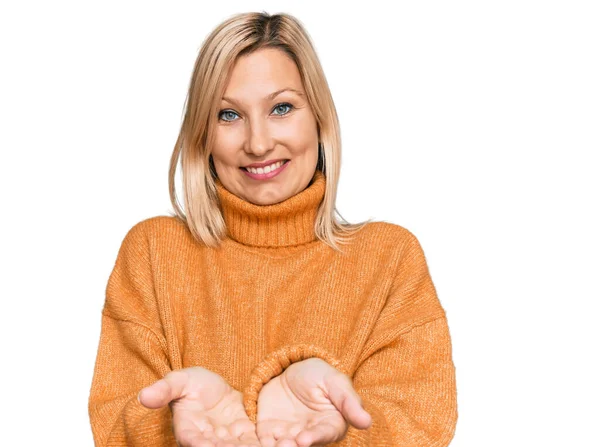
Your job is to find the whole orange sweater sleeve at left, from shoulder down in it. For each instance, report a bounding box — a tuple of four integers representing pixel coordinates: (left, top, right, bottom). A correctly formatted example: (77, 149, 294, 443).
(88, 224, 176, 447)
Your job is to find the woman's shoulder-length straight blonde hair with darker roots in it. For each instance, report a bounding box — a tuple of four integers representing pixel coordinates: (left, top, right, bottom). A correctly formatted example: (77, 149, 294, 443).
(169, 12, 370, 250)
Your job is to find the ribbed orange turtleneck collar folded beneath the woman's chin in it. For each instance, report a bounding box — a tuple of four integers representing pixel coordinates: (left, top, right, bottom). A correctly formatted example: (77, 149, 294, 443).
(215, 170, 325, 247)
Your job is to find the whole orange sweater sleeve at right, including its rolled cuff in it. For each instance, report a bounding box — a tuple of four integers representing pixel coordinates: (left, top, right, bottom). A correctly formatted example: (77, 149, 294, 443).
(245, 233, 458, 447)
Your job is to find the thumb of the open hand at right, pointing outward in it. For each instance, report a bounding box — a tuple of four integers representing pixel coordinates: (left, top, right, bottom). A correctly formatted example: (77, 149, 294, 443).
(327, 374, 372, 429)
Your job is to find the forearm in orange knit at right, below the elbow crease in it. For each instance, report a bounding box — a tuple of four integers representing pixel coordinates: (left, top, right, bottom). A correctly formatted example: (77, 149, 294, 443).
(340, 317, 457, 447)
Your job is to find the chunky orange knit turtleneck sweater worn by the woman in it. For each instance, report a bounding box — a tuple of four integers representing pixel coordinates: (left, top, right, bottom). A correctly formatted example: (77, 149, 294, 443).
(89, 171, 457, 447)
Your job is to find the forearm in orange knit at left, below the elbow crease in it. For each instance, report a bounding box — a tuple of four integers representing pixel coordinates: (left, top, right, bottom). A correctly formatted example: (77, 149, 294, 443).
(88, 315, 175, 447)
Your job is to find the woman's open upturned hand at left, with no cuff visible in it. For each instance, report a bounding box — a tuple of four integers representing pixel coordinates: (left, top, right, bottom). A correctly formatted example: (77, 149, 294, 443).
(138, 367, 260, 447)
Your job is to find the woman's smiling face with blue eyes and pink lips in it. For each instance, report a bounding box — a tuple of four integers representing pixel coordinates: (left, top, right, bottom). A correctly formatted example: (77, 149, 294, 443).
(212, 48, 319, 205)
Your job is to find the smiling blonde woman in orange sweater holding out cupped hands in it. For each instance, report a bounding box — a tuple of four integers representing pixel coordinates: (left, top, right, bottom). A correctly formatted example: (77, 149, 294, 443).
(89, 13, 457, 447)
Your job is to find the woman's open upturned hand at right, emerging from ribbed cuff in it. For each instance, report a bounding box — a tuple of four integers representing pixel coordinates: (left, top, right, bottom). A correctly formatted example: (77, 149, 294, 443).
(256, 358, 372, 447)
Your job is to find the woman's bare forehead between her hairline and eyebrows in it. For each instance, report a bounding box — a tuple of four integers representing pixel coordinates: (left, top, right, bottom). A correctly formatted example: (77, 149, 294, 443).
(225, 48, 304, 99)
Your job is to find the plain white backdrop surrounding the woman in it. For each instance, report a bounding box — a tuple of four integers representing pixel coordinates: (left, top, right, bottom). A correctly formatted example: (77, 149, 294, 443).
(0, 0, 600, 447)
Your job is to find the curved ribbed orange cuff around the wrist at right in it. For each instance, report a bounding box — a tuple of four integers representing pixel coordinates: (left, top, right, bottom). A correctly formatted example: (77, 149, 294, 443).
(243, 344, 348, 423)
